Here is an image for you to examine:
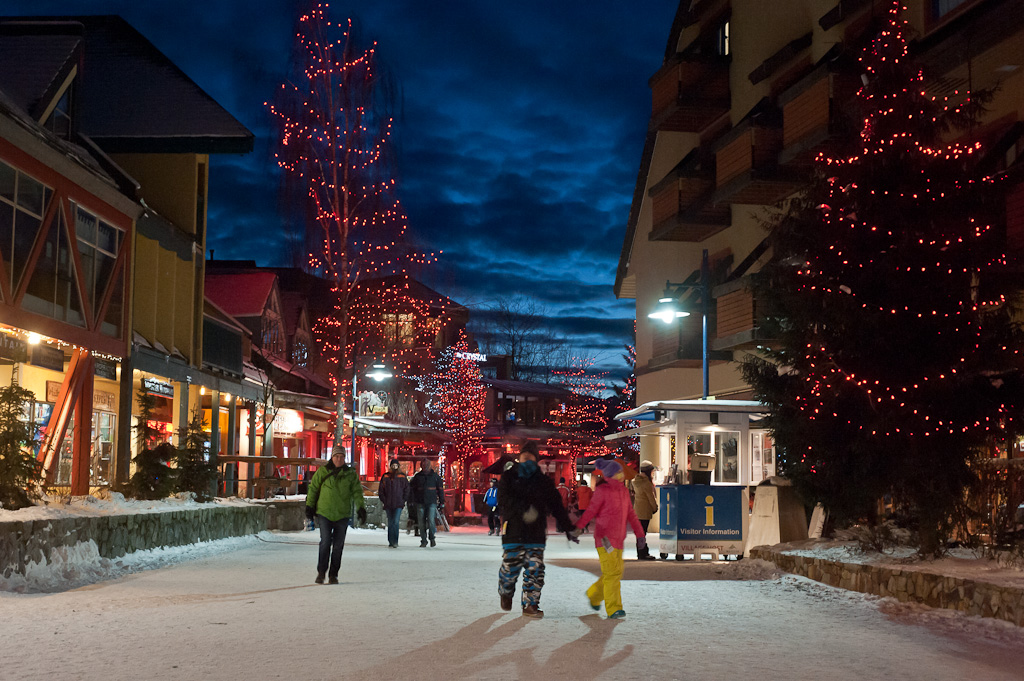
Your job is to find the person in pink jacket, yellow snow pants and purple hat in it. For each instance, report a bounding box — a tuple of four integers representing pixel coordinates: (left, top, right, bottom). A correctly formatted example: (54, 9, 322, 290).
(575, 459, 647, 620)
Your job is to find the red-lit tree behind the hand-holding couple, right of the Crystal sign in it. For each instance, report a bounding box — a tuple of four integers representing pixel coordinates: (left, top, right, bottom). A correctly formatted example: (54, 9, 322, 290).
(545, 357, 609, 480)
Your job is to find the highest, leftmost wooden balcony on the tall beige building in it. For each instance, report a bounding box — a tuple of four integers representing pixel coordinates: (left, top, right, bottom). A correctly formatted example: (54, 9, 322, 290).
(648, 55, 731, 132)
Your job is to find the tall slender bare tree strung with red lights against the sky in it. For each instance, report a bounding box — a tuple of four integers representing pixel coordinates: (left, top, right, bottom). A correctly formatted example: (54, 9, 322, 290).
(268, 3, 436, 445)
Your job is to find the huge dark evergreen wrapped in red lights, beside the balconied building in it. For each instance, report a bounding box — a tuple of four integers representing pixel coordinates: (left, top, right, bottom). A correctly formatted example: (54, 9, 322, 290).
(743, 2, 1024, 555)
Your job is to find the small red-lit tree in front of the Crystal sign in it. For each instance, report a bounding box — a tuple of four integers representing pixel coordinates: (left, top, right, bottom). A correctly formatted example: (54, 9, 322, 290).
(418, 333, 487, 497)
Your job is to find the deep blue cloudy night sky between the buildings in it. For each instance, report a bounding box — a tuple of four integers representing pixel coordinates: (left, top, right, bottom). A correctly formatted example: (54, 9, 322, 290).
(12, 0, 678, 378)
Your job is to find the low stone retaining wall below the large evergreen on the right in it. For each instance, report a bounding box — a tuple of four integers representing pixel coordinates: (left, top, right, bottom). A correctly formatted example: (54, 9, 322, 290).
(751, 546, 1024, 627)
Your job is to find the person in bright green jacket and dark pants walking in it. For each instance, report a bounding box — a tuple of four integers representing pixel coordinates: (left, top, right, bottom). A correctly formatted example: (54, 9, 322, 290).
(306, 448, 367, 584)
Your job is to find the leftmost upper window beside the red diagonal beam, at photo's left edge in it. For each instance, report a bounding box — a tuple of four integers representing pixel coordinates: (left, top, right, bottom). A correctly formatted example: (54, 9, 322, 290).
(0, 162, 53, 290)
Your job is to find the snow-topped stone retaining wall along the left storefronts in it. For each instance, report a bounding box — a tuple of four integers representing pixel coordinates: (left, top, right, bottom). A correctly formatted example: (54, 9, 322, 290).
(0, 505, 267, 578)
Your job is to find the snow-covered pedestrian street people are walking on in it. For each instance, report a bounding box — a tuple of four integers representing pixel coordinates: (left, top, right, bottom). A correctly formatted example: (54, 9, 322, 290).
(0, 528, 1024, 681)
